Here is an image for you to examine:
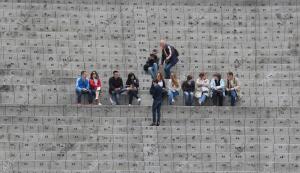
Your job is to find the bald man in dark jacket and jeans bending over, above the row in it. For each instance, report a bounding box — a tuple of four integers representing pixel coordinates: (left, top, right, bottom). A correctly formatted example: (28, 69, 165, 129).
(159, 40, 179, 79)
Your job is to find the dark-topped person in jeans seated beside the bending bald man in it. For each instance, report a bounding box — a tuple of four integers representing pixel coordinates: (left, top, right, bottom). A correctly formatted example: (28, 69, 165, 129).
(144, 49, 159, 80)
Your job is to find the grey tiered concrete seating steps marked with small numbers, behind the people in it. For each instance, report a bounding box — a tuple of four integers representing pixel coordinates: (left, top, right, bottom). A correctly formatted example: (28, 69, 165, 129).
(0, 0, 300, 173)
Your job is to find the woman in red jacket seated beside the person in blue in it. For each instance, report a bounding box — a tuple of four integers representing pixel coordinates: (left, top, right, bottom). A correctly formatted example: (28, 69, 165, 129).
(90, 71, 102, 105)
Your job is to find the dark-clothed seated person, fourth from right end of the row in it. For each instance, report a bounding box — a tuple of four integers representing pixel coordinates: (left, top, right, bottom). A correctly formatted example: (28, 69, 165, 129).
(181, 75, 195, 106)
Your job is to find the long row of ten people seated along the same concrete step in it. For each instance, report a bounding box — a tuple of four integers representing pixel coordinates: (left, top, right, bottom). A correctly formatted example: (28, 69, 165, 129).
(76, 71, 240, 106)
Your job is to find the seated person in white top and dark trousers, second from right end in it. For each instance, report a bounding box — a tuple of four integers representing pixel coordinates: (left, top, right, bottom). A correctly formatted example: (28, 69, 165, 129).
(210, 73, 225, 106)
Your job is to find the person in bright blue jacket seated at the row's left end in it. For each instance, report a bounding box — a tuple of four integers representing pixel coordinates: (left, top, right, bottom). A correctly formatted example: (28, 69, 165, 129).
(76, 71, 93, 104)
